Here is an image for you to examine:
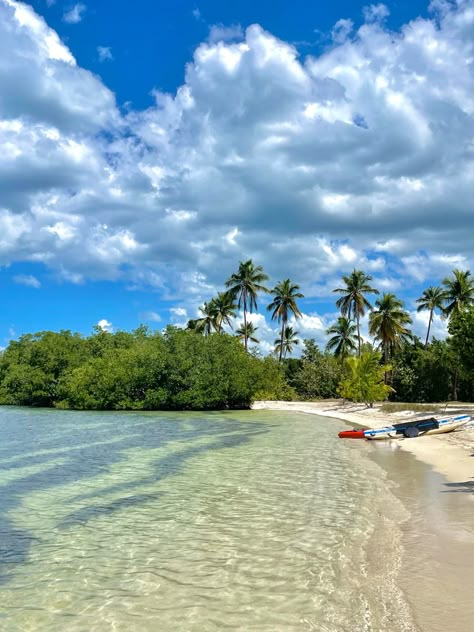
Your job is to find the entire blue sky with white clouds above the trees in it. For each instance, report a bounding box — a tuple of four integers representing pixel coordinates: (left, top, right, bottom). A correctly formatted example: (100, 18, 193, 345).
(0, 0, 474, 353)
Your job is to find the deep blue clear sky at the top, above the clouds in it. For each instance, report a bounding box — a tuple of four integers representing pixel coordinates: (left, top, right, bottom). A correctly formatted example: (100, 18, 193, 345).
(27, 0, 427, 108)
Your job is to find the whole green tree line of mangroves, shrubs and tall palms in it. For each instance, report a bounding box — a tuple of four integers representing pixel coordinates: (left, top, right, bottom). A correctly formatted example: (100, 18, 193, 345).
(0, 260, 474, 410)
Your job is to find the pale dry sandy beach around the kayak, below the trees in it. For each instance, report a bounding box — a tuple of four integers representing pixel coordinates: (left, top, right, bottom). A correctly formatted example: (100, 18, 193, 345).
(252, 400, 474, 484)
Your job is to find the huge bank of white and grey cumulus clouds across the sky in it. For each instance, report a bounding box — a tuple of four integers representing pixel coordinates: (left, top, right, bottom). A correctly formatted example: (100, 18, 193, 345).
(0, 0, 474, 350)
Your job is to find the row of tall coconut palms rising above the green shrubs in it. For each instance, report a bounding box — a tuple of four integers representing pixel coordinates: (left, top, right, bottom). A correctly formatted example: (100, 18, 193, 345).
(187, 259, 474, 362)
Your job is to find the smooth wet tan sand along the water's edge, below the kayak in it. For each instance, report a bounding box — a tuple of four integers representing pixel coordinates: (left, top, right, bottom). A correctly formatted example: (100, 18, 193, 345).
(370, 441, 474, 632)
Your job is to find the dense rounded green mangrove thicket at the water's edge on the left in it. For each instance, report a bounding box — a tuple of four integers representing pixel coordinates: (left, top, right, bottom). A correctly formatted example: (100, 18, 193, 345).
(0, 327, 293, 410)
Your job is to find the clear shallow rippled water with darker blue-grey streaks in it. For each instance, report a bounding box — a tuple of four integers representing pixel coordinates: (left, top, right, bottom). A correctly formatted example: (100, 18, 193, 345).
(0, 408, 418, 632)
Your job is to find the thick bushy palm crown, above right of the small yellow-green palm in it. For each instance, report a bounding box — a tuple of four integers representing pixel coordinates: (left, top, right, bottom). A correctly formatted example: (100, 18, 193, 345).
(369, 293, 411, 363)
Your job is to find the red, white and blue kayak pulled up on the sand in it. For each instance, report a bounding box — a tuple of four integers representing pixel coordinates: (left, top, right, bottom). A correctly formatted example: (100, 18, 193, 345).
(339, 415, 472, 439)
